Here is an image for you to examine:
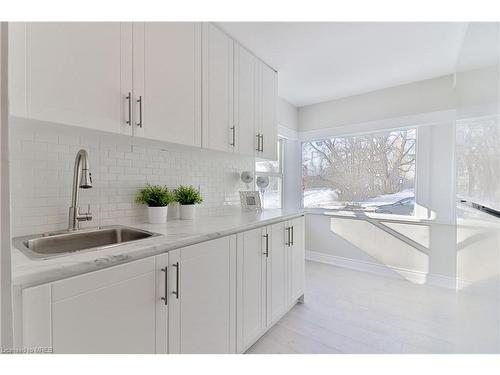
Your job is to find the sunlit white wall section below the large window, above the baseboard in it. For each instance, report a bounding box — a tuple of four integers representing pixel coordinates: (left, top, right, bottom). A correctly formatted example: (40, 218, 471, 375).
(306, 214, 456, 284)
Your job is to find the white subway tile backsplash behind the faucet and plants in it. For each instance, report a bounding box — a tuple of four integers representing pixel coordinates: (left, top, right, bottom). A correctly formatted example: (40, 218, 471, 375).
(10, 118, 254, 236)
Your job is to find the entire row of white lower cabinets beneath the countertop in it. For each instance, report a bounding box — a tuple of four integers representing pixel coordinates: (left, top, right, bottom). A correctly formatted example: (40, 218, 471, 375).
(17, 217, 304, 353)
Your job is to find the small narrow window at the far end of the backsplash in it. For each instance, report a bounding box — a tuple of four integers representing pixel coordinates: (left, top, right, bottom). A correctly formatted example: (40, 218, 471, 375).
(255, 138, 284, 208)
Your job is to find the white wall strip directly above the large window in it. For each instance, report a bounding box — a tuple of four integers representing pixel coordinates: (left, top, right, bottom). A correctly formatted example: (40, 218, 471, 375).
(299, 75, 454, 131)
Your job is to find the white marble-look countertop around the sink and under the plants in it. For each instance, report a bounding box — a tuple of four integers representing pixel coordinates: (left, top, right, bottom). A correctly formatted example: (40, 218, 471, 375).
(12, 210, 304, 288)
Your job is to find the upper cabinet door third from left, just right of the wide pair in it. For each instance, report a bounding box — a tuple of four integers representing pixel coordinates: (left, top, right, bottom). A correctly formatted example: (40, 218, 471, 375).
(202, 23, 234, 151)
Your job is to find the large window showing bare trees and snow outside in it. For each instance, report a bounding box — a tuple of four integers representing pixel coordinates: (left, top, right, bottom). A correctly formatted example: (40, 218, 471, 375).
(302, 129, 416, 215)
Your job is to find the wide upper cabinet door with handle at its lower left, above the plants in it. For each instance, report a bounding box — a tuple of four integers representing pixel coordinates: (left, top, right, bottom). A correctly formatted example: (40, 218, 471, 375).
(134, 22, 201, 147)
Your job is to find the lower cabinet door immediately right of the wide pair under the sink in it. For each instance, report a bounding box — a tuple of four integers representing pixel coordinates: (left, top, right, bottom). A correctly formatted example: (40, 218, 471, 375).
(237, 228, 267, 353)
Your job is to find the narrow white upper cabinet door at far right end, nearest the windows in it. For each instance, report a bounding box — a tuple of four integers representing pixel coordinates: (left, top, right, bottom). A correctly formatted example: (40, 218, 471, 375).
(258, 62, 278, 160)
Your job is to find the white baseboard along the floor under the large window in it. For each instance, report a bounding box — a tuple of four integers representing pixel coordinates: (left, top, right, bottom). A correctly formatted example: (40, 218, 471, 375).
(306, 251, 457, 290)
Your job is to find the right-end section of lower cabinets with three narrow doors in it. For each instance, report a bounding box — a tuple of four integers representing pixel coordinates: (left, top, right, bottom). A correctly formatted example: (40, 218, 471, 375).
(236, 217, 305, 353)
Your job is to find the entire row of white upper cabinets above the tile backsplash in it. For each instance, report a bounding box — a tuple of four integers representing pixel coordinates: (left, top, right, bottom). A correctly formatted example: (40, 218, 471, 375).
(9, 22, 277, 159)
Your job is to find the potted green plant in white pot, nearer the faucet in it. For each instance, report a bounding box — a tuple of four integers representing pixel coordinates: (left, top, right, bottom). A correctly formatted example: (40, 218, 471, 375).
(135, 184, 175, 224)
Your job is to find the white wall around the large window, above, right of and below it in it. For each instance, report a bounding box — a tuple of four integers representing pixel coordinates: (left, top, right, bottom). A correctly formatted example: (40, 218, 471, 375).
(299, 75, 456, 280)
